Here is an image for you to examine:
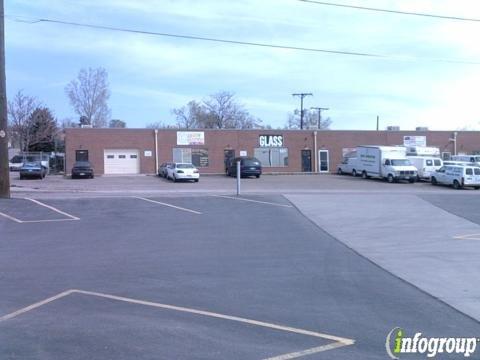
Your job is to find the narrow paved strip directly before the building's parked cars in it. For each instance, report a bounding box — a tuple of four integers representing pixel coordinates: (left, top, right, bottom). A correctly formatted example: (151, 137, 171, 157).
(10, 172, 480, 198)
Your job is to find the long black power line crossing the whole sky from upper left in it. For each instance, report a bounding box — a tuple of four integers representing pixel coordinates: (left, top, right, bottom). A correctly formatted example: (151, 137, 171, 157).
(6, 15, 480, 65)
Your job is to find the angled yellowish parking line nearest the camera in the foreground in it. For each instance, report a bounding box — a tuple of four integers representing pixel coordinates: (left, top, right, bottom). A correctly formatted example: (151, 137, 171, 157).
(0, 289, 355, 360)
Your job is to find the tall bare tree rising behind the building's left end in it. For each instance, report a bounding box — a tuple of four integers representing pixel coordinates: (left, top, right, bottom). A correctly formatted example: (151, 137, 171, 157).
(65, 68, 110, 127)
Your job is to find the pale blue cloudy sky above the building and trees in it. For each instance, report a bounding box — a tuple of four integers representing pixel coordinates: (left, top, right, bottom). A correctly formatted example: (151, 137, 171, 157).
(5, 0, 480, 130)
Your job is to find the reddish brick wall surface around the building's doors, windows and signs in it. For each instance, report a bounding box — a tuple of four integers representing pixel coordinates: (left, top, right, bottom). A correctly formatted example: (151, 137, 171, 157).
(65, 129, 480, 174)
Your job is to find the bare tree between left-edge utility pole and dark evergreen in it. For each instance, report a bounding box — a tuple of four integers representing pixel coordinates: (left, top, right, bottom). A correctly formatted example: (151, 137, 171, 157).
(7, 90, 39, 151)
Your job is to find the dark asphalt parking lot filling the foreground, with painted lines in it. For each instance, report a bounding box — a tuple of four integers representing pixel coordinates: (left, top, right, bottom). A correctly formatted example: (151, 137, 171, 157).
(0, 195, 480, 360)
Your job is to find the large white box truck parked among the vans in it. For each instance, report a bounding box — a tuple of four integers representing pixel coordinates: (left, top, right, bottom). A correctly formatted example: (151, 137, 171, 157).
(352, 145, 418, 183)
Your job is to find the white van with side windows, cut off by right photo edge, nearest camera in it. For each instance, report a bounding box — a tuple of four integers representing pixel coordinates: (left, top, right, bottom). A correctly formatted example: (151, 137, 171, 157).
(431, 165, 480, 189)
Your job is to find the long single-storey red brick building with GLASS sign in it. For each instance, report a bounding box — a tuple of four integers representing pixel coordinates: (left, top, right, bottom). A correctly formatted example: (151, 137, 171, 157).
(65, 128, 480, 174)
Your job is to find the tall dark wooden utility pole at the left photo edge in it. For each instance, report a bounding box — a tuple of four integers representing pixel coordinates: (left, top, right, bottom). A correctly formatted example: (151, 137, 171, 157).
(0, 0, 10, 198)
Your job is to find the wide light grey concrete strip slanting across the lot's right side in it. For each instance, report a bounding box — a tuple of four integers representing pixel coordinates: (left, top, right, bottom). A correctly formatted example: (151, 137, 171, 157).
(286, 194, 480, 320)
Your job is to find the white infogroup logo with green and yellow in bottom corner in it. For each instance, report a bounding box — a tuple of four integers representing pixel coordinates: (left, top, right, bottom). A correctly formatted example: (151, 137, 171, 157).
(385, 327, 480, 359)
